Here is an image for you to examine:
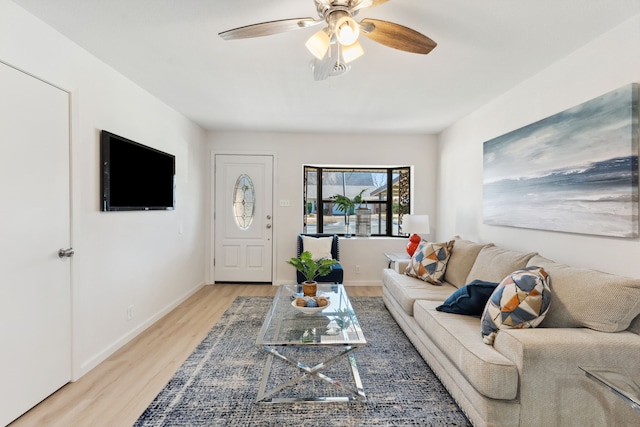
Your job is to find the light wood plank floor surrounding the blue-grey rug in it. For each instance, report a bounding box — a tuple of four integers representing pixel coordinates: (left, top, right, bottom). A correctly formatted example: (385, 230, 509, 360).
(9, 284, 382, 427)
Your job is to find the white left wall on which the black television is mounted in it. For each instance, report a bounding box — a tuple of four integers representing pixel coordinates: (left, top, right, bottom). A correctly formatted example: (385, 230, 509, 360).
(0, 0, 208, 378)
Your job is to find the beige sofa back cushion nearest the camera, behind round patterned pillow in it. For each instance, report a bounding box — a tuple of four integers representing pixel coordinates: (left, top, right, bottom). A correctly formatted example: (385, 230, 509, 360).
(529, 256, 640, 332)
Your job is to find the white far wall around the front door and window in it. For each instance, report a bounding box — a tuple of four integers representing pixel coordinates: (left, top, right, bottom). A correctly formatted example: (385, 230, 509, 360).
(208, 132, 437, 285)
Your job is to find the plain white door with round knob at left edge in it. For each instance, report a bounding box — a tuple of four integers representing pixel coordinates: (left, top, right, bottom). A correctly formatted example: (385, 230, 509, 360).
(0, 63, 71, 425)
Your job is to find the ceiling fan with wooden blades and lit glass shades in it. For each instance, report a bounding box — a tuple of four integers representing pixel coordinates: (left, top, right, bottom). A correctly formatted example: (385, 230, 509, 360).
(218, 0, 436, 80)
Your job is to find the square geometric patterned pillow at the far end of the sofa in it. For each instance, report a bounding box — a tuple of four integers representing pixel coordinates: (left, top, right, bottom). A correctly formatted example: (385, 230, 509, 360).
(404, 240, 455, 285)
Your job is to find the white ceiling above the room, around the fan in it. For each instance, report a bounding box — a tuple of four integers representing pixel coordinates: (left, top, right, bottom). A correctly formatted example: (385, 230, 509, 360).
(14, 0, 640, 133)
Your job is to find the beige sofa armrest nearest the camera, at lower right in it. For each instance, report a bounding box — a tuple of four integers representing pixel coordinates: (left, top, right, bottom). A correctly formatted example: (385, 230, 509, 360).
(494, 328, 640, 425)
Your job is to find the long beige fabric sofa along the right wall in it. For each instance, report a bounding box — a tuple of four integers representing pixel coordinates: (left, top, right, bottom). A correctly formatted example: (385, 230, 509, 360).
(383, 238, 640, 427)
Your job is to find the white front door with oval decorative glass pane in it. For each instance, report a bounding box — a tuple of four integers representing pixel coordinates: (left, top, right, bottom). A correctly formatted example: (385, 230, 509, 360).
(214, 155, 273, 282)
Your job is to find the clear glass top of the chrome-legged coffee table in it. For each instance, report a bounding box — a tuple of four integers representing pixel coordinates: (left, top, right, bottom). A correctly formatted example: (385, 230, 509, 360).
(256, 284, 367, 346)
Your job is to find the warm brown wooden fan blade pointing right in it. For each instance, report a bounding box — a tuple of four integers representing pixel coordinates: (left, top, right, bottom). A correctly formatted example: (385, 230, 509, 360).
(360, 18, 437, 55)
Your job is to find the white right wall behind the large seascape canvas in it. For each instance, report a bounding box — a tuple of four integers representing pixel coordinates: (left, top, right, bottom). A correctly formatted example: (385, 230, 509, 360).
(437, 15, 640, 277)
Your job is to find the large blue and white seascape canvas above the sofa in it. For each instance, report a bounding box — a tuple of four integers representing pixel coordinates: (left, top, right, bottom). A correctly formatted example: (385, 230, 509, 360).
(483, 83, 638, 238)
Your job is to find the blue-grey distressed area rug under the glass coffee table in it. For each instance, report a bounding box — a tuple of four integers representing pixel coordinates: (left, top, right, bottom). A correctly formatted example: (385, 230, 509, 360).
(134, 297, 471, 427)
